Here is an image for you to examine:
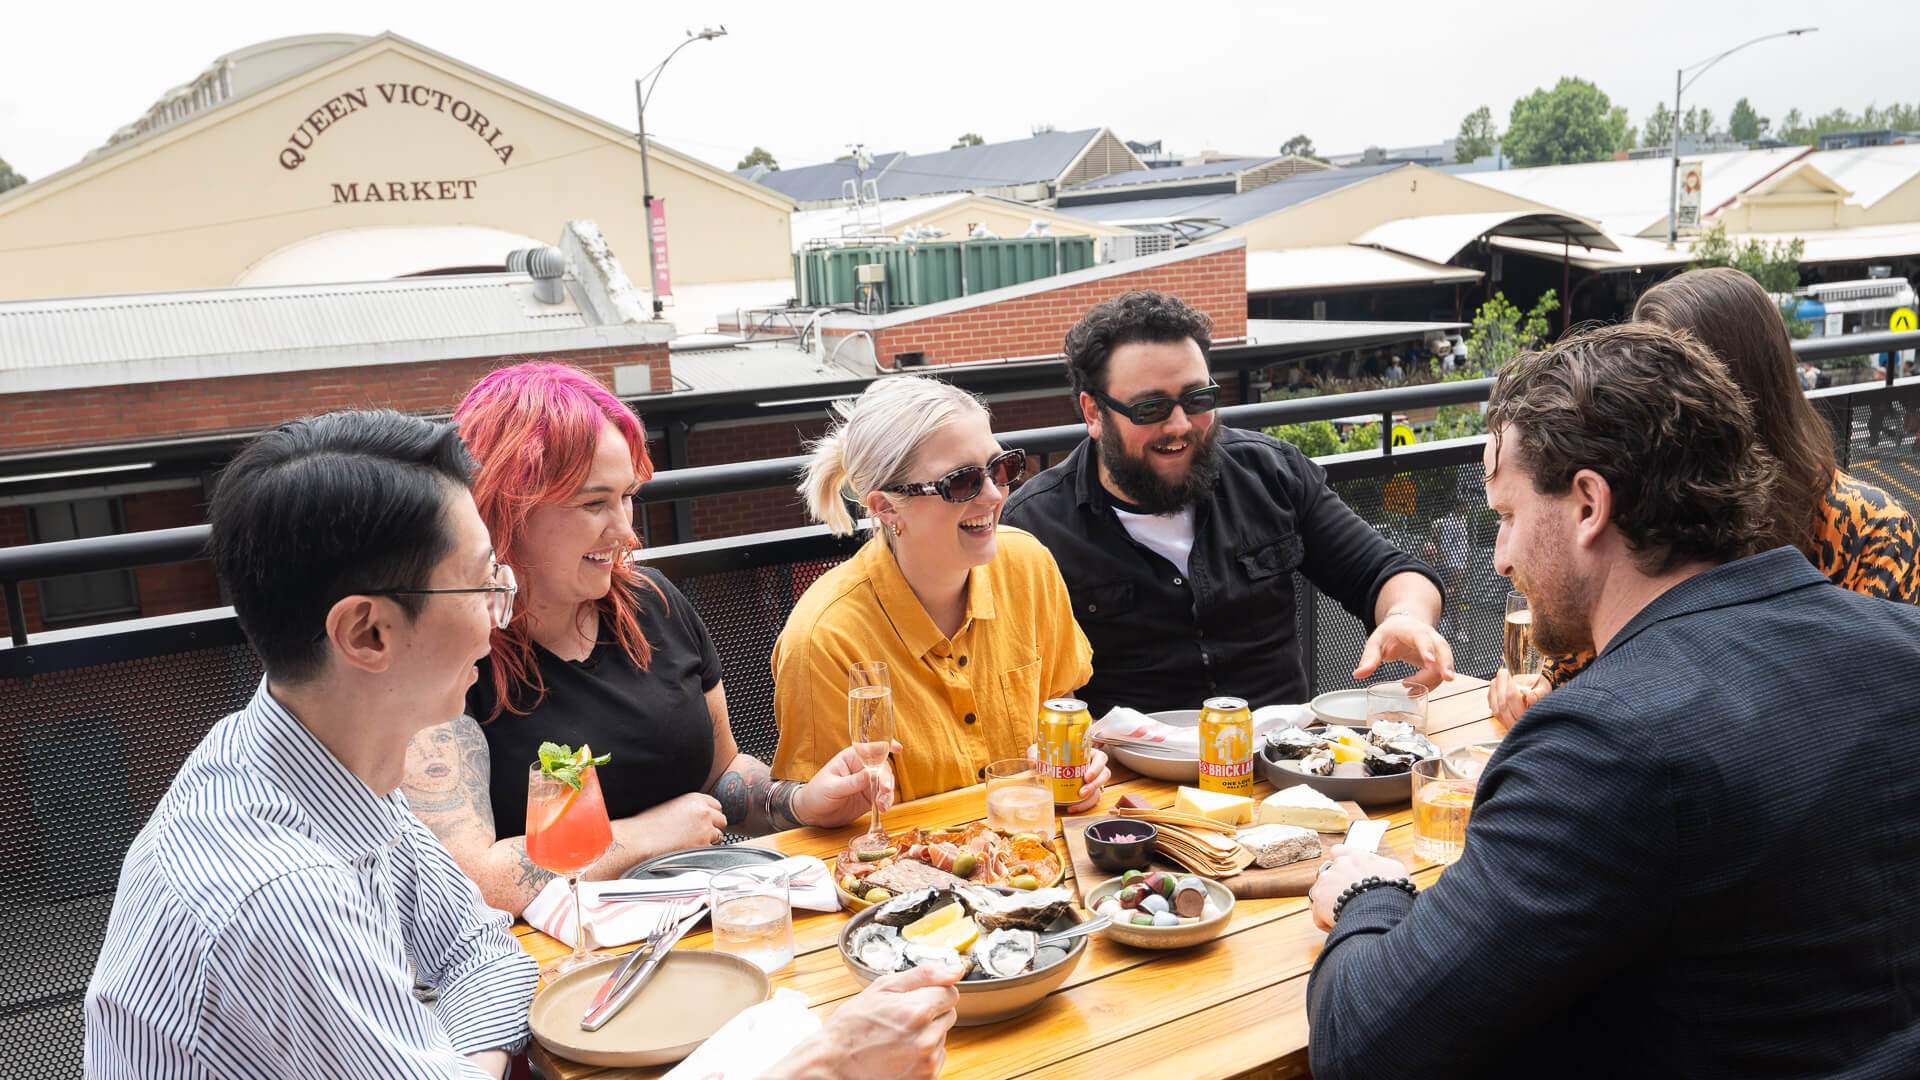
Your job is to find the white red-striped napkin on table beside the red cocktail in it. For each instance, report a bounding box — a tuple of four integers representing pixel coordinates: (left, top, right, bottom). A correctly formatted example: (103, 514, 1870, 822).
(520, 855, 839, 949)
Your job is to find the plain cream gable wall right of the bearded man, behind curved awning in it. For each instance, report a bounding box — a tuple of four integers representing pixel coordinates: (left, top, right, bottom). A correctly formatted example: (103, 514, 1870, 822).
(1210, 165, 1565, 252)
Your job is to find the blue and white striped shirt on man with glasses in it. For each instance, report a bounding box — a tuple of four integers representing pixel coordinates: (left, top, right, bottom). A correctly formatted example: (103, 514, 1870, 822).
(86, 680, 536, 1080)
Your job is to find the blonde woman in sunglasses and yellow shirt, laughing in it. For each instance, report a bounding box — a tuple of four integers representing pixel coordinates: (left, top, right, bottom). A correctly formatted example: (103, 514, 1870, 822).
(774, 375, 1108, 809)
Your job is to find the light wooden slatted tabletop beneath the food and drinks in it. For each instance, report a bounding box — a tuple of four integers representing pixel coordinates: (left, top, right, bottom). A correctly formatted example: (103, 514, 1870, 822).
(515, 676, 1501, 1080)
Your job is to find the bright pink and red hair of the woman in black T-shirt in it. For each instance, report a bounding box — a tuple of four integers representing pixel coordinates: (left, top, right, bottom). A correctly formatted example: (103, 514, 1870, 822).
(453, 363, 666, 723)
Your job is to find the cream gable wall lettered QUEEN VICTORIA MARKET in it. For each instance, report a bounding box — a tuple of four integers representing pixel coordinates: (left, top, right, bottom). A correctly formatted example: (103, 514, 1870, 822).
(0, 38, 791, 298)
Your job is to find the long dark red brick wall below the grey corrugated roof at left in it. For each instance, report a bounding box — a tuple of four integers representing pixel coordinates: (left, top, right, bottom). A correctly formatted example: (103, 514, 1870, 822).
(0, 344, 672, 450)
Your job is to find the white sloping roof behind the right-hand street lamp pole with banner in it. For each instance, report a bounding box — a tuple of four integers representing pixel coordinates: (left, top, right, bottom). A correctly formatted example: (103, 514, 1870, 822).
(1455, 146, 1807, 236)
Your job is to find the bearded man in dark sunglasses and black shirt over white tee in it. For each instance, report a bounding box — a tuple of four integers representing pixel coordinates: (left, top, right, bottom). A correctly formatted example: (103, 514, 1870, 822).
(1004, 292, 1453, 715)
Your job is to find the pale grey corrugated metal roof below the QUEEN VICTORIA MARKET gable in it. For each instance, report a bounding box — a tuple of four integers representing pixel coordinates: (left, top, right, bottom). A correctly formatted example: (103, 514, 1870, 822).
(0, 273, 595, 374)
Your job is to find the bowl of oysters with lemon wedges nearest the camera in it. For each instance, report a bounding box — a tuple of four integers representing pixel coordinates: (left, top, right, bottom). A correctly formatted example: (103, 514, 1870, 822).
(839, 884, 1087, 1026)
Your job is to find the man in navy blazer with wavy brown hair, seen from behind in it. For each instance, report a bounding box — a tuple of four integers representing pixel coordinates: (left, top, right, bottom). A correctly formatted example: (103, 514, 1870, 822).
(1308, 325, 1920, 1080)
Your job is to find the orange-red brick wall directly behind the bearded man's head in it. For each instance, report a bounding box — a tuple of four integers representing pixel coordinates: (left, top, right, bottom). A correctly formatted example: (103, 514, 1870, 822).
(826, 248, 1246, 367)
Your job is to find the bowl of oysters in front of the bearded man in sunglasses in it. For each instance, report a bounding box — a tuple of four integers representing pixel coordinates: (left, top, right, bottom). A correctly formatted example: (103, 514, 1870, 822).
(1254, 721, 1440, 807)
